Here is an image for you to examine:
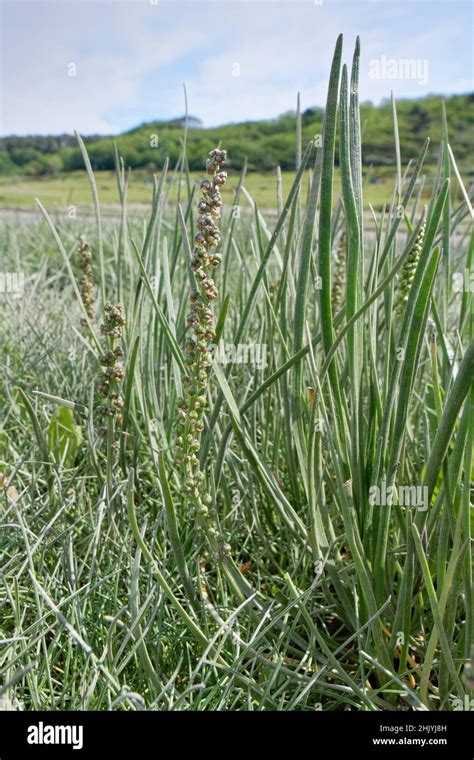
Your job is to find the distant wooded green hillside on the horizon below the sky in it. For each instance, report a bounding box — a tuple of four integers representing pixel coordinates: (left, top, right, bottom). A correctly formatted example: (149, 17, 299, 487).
(0, 94, 474, 176)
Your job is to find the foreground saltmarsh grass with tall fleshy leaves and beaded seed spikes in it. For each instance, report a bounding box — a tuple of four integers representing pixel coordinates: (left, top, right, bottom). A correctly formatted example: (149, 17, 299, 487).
(0, 37, 474, 710)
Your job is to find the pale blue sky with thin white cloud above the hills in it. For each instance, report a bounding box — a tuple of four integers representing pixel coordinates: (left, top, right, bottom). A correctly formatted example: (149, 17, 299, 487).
(0, 0, 473, 135)
